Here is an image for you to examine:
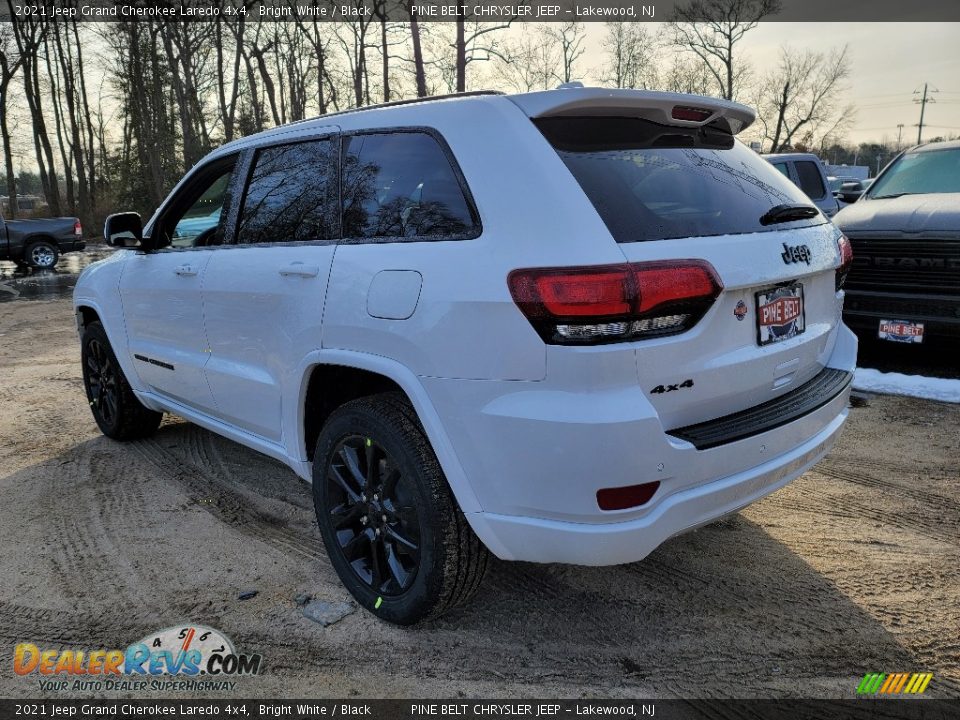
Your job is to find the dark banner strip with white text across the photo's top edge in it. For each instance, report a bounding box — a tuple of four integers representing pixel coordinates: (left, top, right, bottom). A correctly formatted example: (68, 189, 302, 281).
(0, 0, 960, 23)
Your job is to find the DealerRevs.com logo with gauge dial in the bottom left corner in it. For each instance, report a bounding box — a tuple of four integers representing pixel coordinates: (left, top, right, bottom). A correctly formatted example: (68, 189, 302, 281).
(13, 625, 261, 692)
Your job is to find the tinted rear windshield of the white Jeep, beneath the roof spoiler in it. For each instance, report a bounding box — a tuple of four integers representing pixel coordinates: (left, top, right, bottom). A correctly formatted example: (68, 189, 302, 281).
(534, 117, 826, 242)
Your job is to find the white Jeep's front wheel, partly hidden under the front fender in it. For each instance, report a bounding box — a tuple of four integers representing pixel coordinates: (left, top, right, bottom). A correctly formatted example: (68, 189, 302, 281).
(80, 321, 163, 441)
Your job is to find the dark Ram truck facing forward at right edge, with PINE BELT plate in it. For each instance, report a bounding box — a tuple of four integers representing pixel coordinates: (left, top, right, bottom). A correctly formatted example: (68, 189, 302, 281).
(836, 142, 960, 343)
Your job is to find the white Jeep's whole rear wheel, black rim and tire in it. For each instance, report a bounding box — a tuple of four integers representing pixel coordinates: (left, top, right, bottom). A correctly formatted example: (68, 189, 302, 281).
(313, 393, 489, 625)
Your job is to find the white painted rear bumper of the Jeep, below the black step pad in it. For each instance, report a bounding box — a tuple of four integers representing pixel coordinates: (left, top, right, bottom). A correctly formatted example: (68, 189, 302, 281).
(421, 325, 857, 565)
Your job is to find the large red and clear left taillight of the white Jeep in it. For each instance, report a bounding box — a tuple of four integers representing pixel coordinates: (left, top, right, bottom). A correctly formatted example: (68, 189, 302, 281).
(507, 260, 723, 345)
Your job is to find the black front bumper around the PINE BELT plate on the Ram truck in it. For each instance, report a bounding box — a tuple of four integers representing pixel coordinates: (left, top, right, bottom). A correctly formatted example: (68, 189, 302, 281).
(843, 290, 960, 340)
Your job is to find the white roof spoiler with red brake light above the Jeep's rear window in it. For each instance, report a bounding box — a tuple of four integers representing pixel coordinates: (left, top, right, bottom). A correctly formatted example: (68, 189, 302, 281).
(508, 88, 757, 135)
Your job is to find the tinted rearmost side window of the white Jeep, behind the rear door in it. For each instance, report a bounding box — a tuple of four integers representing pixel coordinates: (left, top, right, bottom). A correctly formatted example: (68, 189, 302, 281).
(342, 132, 479, 239)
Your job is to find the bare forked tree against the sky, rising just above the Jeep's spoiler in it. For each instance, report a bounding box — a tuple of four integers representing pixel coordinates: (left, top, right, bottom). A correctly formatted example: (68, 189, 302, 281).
(671, 0, 780, 100)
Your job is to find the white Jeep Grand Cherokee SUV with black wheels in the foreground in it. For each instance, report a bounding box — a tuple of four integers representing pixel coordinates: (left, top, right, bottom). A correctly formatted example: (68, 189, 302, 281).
(74, 89, 856, 623)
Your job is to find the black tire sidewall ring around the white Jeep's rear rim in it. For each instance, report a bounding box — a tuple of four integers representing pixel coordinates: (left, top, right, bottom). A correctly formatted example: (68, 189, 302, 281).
(313, 406, 444, 625)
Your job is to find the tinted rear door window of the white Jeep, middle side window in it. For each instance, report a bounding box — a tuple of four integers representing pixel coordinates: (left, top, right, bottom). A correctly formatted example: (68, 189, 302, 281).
(237, 139, 340, 244)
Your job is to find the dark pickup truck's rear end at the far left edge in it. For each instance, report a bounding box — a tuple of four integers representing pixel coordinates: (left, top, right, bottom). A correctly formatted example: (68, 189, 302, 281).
(0, 218, 87, 269)
